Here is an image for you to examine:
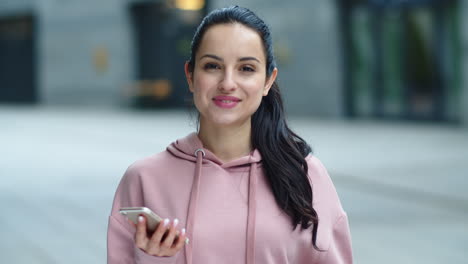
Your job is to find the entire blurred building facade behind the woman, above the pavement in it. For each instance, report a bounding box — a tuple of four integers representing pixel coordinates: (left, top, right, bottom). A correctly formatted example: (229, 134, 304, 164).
(0, 0, 468, 124)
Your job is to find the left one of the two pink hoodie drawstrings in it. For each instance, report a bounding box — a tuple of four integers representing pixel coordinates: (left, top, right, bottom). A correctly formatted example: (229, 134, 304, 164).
(185, 149, 205, 264)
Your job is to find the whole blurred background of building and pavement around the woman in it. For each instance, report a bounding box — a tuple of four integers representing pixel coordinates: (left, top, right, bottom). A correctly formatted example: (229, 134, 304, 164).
(0, 0, 468, 263)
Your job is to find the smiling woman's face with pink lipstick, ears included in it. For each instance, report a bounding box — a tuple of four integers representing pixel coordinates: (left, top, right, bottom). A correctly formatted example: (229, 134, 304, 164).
(185, 23, 277, 126)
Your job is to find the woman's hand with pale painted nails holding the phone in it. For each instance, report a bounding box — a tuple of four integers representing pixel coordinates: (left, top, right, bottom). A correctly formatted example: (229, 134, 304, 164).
(133, 216, 187, 257)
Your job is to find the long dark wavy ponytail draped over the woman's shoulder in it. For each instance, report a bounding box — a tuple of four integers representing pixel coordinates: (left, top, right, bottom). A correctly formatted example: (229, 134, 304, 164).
(252, 82, 320, 250)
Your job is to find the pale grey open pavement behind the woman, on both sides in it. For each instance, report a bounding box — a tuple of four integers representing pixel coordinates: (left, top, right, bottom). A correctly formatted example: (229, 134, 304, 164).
(0, 105, 468, 264)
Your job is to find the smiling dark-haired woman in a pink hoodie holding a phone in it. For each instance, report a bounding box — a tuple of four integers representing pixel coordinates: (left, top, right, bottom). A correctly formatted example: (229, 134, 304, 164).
(108, 6, 352, 264)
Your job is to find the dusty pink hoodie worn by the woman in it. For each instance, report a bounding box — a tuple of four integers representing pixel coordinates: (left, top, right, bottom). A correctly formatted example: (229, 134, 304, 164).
(107, 133, 352, 264)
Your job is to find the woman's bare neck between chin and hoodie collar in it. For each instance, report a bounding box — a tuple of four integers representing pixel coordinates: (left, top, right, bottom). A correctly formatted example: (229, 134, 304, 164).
(198, 119, 252, 162)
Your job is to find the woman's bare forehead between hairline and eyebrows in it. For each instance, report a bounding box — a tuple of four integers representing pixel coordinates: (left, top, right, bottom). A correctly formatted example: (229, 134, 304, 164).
(197, 23, 265, 62)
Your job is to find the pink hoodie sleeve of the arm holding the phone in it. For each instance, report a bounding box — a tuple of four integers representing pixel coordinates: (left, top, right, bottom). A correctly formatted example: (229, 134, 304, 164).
(107, 166, 179, 264)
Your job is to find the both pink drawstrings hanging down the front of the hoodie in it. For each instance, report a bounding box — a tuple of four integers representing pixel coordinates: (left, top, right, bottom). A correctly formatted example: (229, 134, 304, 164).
(185, 149, 257, 264)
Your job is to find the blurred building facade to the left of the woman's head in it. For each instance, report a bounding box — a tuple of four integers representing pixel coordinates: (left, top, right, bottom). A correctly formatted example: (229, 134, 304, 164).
(0, 0, 203, 106)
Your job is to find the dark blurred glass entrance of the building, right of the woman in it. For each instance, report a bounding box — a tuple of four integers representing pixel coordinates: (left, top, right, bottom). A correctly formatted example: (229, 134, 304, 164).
(339, 0, 464, 122)
